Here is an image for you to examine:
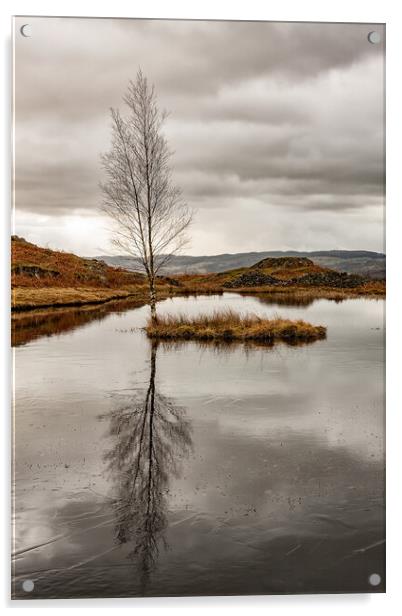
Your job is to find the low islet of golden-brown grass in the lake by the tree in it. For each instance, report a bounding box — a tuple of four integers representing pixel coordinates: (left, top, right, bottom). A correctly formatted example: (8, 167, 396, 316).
(145, 310, 326, 344)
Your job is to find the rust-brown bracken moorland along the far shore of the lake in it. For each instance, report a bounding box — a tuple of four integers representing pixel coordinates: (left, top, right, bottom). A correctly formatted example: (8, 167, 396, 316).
(11, 236, 385, 311)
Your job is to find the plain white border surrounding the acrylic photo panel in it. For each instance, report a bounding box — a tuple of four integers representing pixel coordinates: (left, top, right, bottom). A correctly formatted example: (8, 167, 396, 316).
(0, 0, 402, 616)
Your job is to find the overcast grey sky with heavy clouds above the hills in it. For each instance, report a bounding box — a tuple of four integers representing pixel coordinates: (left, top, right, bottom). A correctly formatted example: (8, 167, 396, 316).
(15, 18, 385, 256)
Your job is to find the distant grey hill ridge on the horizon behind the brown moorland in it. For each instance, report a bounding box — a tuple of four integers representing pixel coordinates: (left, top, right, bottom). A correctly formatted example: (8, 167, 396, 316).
(98, 250, 386, 279)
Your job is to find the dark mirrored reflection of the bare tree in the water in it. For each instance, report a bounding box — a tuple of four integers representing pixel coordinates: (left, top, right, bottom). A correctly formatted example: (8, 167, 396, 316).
(105, 343, 192, 588)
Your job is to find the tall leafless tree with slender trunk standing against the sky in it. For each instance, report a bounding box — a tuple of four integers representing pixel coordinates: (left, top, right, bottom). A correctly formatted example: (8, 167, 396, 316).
(101, 70, 192, 322)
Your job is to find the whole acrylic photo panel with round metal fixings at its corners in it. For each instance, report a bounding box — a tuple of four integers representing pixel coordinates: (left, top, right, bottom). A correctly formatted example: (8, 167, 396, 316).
(11, 16, 385, 599)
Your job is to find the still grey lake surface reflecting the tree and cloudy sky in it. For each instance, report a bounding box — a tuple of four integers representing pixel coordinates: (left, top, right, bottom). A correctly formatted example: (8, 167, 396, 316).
(13, 293, 385, 598)
